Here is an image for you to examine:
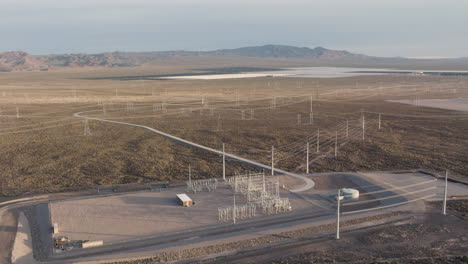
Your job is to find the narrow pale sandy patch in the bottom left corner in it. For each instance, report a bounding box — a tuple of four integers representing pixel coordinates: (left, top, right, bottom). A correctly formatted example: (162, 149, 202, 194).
(11, 212, 36, 264)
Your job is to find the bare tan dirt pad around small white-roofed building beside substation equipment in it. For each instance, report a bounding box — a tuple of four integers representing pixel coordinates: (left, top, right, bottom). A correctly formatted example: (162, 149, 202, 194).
(50, 186, 319, 243)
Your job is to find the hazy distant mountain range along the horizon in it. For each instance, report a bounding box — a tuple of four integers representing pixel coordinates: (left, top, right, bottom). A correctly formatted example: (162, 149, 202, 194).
(0, 45, 468, 72)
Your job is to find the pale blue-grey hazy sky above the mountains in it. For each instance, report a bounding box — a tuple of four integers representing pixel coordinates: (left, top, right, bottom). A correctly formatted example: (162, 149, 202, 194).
(0, 0, 468, 57)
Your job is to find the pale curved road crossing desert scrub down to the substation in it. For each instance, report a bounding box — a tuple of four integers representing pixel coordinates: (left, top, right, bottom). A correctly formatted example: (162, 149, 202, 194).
(73, 112, 315, 192)
